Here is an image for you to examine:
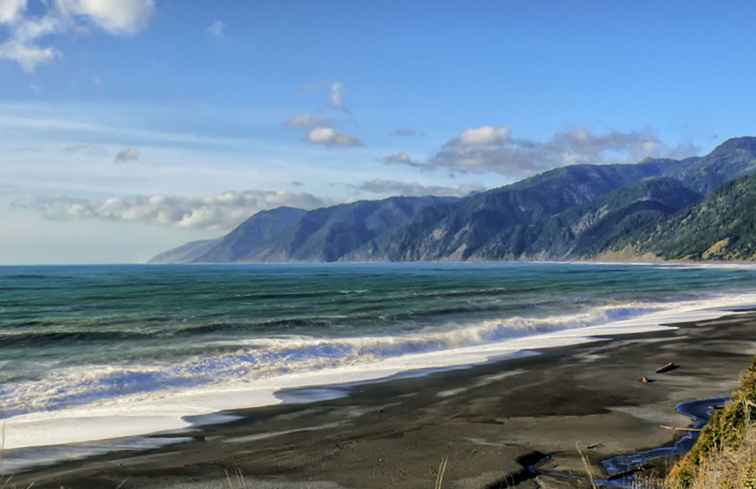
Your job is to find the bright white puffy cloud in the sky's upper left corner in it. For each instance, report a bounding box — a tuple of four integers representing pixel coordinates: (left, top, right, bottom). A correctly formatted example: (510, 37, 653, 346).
(0, 0, 155, 73)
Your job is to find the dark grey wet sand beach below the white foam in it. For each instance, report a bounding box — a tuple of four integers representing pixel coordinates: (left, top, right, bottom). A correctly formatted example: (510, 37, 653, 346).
(12, 313, 756, 489)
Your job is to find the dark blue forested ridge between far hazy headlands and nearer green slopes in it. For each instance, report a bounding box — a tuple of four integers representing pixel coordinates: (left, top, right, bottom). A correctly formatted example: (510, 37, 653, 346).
(385, 162, 664, 261)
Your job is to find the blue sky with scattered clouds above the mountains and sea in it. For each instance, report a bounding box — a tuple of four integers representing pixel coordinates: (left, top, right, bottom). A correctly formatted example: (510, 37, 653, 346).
(0, 0, 756, 265)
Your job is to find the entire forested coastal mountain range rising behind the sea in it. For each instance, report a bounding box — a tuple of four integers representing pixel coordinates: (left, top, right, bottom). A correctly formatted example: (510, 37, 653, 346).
(151, 137, 756, 263)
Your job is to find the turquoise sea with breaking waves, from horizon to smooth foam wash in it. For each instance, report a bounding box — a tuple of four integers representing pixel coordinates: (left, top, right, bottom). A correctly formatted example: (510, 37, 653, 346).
(0, 263, 756, 418)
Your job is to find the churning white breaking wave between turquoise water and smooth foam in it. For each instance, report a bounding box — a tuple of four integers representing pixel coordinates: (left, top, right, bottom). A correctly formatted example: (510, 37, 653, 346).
(0, 302, 704, 418)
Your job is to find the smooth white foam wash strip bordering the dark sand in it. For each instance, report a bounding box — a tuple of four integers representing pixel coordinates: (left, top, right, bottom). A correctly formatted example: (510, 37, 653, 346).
(0, 294, 756, 454)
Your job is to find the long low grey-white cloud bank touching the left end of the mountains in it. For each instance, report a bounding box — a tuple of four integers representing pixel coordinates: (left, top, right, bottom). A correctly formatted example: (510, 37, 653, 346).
(14, 190, 331, 231)
